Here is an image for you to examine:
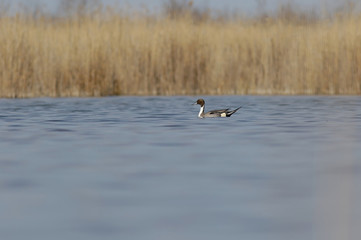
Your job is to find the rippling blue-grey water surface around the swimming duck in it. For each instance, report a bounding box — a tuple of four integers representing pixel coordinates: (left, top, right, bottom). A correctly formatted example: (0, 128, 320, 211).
(0, 96, 361, 240)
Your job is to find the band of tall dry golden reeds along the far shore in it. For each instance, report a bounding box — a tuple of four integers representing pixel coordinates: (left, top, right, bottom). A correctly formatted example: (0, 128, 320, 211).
(0, 3, 361, 98)
